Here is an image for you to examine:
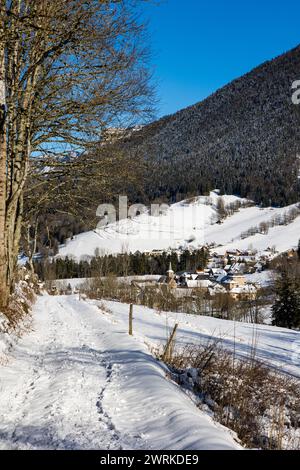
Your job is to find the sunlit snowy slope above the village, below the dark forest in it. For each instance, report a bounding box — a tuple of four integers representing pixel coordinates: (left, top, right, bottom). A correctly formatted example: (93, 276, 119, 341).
(58, 192, 300, 259)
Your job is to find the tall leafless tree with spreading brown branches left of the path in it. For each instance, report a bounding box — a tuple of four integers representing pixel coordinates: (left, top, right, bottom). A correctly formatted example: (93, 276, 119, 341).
(0, 0, 150, 307)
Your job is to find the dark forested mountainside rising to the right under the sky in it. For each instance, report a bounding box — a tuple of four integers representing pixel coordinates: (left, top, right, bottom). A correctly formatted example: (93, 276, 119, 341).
(122, 46, 300, 205)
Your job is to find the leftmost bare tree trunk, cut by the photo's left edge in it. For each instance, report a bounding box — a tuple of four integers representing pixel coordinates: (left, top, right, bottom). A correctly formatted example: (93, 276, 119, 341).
(0, 18, 9, 308)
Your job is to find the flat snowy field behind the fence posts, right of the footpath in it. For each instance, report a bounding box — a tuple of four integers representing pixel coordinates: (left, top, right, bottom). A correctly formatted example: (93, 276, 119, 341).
(100, 301, 300, 377)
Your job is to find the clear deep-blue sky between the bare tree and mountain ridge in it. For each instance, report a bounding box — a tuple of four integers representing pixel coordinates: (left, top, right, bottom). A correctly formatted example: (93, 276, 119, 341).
(145, 0, 300, 116)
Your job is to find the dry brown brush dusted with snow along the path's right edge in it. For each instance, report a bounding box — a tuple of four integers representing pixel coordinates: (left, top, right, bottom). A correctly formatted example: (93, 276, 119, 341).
(163, 341, 300, 450)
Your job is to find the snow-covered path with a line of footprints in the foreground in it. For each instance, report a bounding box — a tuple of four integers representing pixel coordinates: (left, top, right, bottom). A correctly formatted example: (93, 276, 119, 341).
(0, 296, 239, 450)
